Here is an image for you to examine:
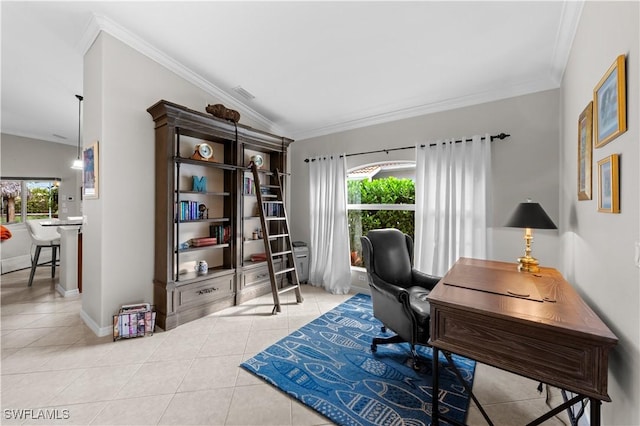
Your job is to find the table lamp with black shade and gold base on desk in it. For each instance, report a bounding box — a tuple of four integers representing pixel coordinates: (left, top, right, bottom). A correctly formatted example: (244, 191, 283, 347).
(505, 200, 558, 272)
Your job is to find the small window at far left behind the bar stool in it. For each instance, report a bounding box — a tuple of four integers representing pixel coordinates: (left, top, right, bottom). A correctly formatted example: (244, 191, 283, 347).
(0, 178, 60, 224)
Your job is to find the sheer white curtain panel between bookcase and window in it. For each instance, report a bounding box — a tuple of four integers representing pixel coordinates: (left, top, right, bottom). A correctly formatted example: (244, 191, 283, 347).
(309, 154, 351, 294)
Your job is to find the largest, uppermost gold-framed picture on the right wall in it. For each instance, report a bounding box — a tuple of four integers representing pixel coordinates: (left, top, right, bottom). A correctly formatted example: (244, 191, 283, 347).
(593, 55, 627, 148)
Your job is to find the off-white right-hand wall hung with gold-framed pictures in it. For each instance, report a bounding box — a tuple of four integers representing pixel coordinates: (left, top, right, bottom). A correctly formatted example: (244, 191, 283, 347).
(560, 2, 640, 425)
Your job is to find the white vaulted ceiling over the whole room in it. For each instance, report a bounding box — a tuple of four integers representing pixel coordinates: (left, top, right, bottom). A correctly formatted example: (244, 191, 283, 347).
(0, 1, 582, 145)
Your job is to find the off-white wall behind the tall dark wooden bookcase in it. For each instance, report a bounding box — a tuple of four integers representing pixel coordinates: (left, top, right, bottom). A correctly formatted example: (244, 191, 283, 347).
(82, 32, 266, 335)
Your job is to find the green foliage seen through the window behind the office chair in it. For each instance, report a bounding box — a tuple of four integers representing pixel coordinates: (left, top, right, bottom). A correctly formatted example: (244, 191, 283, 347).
(347, 177, 416, 266)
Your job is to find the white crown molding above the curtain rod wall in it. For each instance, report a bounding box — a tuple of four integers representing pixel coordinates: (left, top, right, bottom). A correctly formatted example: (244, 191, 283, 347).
(291, 78, 559, 140)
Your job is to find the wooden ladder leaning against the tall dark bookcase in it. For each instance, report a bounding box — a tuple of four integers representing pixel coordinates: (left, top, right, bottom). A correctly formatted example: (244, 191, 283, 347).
(250, 163, 303, 314)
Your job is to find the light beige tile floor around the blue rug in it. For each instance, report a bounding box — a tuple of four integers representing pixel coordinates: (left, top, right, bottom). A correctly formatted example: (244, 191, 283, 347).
(0, 268, 569, 425)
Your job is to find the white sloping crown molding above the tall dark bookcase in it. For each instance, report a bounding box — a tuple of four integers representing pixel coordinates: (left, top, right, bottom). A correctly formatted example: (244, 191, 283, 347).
(77, 14, 282, 134)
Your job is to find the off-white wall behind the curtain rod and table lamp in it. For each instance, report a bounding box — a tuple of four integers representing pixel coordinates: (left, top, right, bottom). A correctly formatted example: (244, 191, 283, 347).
(289, 90, 559, 272)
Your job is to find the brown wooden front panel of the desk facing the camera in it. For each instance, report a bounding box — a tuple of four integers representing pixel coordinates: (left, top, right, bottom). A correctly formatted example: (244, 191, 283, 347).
(431, 302, 610, 401)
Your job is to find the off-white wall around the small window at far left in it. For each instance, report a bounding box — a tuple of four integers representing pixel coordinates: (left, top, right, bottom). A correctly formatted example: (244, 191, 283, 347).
(0, 134, 81, 273)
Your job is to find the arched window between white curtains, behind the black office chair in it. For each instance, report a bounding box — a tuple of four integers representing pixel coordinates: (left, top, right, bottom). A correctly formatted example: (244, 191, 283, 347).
(347, 162, 415, 267)
